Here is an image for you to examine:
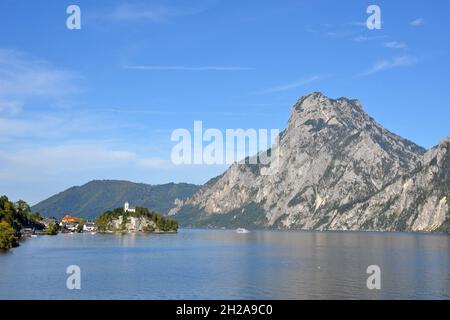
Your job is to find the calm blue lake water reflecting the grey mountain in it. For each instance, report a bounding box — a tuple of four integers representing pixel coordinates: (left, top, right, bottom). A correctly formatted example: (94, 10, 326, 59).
(0, 229, 450, 299)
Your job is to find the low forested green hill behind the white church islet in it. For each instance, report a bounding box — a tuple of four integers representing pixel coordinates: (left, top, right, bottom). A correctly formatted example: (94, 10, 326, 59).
(32, 180, 199, 219)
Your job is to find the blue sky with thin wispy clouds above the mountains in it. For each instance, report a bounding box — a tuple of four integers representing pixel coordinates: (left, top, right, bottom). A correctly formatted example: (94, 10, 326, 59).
(0, 0, 450, 203)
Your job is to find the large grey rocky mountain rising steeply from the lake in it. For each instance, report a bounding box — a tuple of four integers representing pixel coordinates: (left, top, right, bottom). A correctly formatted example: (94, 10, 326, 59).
(169, 92, 450, 231)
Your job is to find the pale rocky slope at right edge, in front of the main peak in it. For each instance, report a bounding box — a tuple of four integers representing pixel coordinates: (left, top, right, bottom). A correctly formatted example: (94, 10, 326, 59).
(322, 140, 450, 231)
